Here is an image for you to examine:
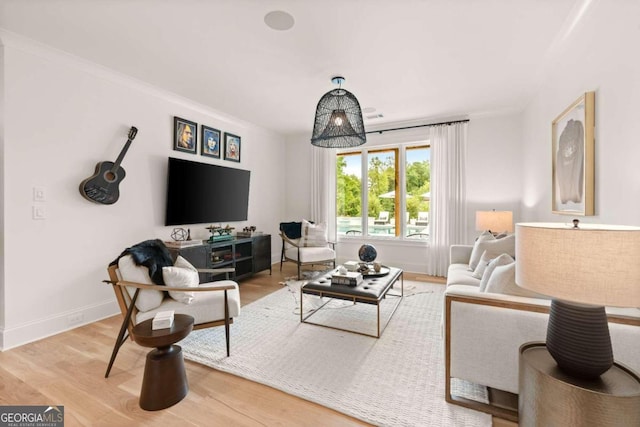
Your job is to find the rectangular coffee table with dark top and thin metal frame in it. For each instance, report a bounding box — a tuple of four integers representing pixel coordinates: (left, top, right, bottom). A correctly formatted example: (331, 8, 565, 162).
(300, 267, 404, 338)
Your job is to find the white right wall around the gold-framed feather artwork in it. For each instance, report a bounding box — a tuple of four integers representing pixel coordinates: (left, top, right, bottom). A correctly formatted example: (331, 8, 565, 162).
(522, 1, 640, 225)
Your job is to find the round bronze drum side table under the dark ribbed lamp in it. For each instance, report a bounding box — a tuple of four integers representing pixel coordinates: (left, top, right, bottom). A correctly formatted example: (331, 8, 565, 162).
(518, 342, 640, 427)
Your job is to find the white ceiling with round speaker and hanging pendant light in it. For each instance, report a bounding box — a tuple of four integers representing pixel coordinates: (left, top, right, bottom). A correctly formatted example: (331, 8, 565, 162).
(0, 0, 590, 134)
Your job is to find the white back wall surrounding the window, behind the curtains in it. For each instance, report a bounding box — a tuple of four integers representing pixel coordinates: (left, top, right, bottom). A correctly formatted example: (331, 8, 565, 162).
(283, 113, 522, 272)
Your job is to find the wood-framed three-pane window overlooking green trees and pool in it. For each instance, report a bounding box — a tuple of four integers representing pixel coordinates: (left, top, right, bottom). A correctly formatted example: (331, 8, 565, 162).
(336, 143, 431, 239)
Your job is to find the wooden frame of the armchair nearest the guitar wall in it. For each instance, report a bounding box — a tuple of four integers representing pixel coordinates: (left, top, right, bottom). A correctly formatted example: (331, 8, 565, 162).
(103, 265, 235, 378)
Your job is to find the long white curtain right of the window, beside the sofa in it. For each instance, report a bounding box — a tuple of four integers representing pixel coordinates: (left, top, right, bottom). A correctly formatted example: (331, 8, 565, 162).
(427, 122, 468, 276)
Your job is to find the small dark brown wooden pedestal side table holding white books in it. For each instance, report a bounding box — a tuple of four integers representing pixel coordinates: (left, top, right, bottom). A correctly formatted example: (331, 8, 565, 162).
(133, 314, 193, 411)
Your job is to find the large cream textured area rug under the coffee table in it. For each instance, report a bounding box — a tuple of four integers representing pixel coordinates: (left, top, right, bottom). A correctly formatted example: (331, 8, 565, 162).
(180, 281, 491, 427)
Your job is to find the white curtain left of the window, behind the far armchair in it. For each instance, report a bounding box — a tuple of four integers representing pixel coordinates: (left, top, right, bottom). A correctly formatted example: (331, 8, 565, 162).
(310, 146, 336, 242)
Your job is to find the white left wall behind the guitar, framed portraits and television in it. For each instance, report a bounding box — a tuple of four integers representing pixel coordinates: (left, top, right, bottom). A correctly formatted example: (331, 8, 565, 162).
(0, 33, 285, 349)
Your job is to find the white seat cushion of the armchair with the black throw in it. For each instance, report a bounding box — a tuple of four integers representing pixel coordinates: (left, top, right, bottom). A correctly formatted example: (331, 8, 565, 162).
(135, 280, 240, 325)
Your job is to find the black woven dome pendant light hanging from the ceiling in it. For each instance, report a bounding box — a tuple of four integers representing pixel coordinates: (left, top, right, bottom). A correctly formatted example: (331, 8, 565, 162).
(311, 77, 367, 148)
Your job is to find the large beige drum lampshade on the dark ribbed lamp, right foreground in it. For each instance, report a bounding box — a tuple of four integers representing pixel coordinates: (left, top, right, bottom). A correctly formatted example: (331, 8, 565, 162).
(516, 223, 640, 307)
